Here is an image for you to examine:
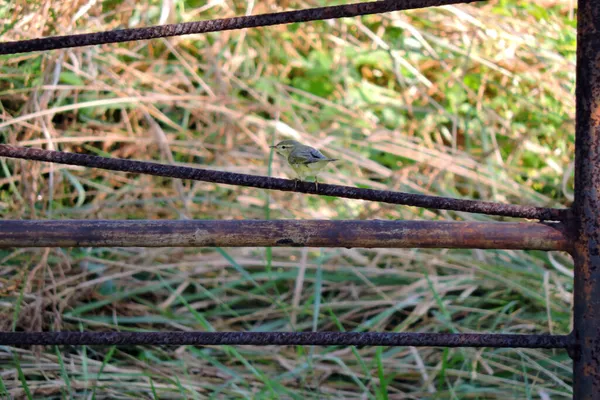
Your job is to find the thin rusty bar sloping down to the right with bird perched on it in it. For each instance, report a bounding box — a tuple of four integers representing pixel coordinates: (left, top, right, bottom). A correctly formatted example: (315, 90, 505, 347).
(0, 144, 568, 221)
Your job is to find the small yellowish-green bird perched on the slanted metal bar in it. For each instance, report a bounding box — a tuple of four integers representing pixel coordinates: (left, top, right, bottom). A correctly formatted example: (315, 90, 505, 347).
(269, 140, 337, 190)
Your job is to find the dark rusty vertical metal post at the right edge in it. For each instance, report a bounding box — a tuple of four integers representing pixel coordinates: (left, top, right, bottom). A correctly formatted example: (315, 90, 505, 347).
(570, 0, 600, 400)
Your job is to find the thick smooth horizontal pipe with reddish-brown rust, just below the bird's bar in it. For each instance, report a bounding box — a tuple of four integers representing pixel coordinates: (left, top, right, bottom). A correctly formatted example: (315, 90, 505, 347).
(0, 220, 569, 250)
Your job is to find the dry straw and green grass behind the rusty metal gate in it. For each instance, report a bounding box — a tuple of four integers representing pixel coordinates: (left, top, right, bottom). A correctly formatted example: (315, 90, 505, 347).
(0, 0, 576, 400)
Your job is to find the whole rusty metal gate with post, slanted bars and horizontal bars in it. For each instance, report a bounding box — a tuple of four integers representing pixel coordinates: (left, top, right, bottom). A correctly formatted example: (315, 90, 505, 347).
(0, 0, 600, 399)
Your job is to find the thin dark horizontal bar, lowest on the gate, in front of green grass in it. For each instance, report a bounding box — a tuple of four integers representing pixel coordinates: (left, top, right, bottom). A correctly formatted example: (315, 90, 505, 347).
(0, 332, 571, 349)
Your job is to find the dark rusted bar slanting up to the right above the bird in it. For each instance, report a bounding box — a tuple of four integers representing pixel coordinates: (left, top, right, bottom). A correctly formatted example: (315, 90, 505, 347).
(0, 0, 482, 54)
